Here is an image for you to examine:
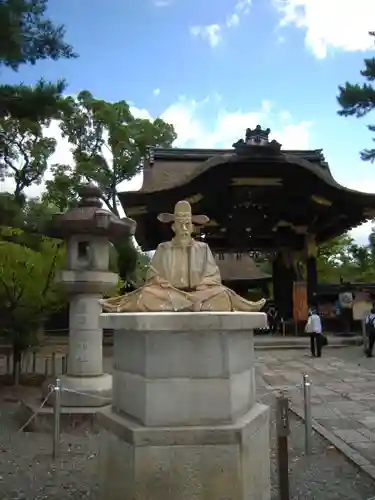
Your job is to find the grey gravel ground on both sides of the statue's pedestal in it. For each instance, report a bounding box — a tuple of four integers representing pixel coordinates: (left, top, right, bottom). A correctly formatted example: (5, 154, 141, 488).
(0, 396, 375, 500)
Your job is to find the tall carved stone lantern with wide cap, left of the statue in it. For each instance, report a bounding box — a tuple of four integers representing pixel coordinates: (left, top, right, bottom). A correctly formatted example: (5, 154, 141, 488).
(53, 184, 136, 406)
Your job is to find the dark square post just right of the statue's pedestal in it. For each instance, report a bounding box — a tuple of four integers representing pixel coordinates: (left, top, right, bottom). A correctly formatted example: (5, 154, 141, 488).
(276, 394, 290, 500)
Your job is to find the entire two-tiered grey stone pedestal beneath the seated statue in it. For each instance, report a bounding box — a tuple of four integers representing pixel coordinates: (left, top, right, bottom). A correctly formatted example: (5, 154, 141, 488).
(98, 312, 270, 500)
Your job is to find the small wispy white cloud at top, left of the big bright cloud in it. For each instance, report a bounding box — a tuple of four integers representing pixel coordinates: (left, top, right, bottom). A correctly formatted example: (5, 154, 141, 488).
(190, 0, 252, 47)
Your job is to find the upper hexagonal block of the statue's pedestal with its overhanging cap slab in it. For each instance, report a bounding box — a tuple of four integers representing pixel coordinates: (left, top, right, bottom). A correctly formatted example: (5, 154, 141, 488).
(101, 312, 266, 427)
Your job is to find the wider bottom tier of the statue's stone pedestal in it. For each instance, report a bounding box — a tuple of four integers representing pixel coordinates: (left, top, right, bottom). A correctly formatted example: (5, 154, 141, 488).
(98, 404, 270, 500)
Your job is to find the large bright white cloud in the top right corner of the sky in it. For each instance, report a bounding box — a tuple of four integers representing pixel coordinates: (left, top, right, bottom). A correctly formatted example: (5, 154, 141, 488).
(273, 0, 375, 59)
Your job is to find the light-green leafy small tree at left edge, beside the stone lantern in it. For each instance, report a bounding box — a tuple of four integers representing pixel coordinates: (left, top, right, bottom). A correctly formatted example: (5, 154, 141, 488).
(0, 228, 66, 382)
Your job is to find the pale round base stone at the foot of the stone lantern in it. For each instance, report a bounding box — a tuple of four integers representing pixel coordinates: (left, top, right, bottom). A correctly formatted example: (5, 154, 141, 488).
(43, 373, 112, 407)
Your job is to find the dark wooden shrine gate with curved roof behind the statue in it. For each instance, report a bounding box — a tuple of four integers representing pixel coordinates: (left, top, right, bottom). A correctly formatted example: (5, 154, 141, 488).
(119, 125, 375, 319)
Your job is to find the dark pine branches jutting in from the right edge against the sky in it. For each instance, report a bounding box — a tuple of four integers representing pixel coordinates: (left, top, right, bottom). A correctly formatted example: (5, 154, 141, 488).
(337, 32, 375, 162)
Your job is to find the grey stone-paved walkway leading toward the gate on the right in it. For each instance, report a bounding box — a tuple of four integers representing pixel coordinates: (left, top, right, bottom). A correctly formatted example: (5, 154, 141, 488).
(256, 347, 375, 478)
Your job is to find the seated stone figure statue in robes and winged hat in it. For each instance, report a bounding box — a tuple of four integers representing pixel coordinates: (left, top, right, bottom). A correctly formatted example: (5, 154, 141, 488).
(100, 201, 265, 313)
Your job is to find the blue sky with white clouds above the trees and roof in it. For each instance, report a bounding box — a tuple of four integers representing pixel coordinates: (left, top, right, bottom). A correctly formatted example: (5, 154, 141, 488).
(0, 0, 375, 243)
